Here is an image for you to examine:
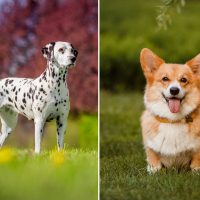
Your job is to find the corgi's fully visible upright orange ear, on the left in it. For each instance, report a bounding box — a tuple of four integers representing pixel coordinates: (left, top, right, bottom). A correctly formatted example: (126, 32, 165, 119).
(140, 48, 165, 78)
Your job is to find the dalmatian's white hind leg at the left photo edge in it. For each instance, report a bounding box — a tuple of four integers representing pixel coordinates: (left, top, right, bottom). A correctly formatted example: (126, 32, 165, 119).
(0, 107, 18, 147)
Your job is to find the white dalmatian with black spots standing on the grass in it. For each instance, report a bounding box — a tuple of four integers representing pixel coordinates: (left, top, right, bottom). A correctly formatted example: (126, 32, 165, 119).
(0, 41, 78, 153)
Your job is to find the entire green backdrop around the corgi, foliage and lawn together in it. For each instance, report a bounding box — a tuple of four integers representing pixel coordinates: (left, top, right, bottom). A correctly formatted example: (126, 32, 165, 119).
(100, 0, 200, 200)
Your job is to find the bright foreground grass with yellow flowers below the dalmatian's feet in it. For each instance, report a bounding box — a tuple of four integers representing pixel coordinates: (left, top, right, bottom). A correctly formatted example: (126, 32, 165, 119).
(0, 149, 98, 200)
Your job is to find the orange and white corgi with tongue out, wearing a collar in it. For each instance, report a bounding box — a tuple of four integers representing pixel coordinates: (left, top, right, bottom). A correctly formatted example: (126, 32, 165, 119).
(140, 48, 200, 173)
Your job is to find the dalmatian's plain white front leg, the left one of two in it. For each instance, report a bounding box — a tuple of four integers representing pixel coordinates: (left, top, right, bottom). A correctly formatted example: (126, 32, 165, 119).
(34, 118, 44, 153)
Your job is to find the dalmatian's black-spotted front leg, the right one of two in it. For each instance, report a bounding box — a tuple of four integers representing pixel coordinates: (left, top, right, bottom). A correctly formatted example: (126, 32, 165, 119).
(56, 116, 67, 150)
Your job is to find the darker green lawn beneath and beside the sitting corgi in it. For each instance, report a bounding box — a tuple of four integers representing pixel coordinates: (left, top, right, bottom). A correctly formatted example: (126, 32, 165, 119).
(100, 91, 200, 200)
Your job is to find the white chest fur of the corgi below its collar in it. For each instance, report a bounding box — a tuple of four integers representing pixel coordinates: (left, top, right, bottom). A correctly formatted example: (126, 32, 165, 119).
(147, 123, 200, 156)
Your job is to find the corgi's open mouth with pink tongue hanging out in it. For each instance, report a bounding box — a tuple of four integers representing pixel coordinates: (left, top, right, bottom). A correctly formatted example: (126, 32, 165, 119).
(163, 94, 183, 113)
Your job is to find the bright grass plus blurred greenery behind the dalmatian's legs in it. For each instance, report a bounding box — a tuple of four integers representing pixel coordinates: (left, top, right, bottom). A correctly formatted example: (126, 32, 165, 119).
(0, 114, 98, 200)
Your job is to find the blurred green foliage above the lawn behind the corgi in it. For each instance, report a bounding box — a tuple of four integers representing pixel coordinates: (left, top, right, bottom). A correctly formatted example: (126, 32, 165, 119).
(100, 0, 200, 91)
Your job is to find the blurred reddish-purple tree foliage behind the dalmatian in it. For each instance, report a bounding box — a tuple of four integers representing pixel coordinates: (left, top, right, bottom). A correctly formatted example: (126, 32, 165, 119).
(0, 0, 98, 112)
